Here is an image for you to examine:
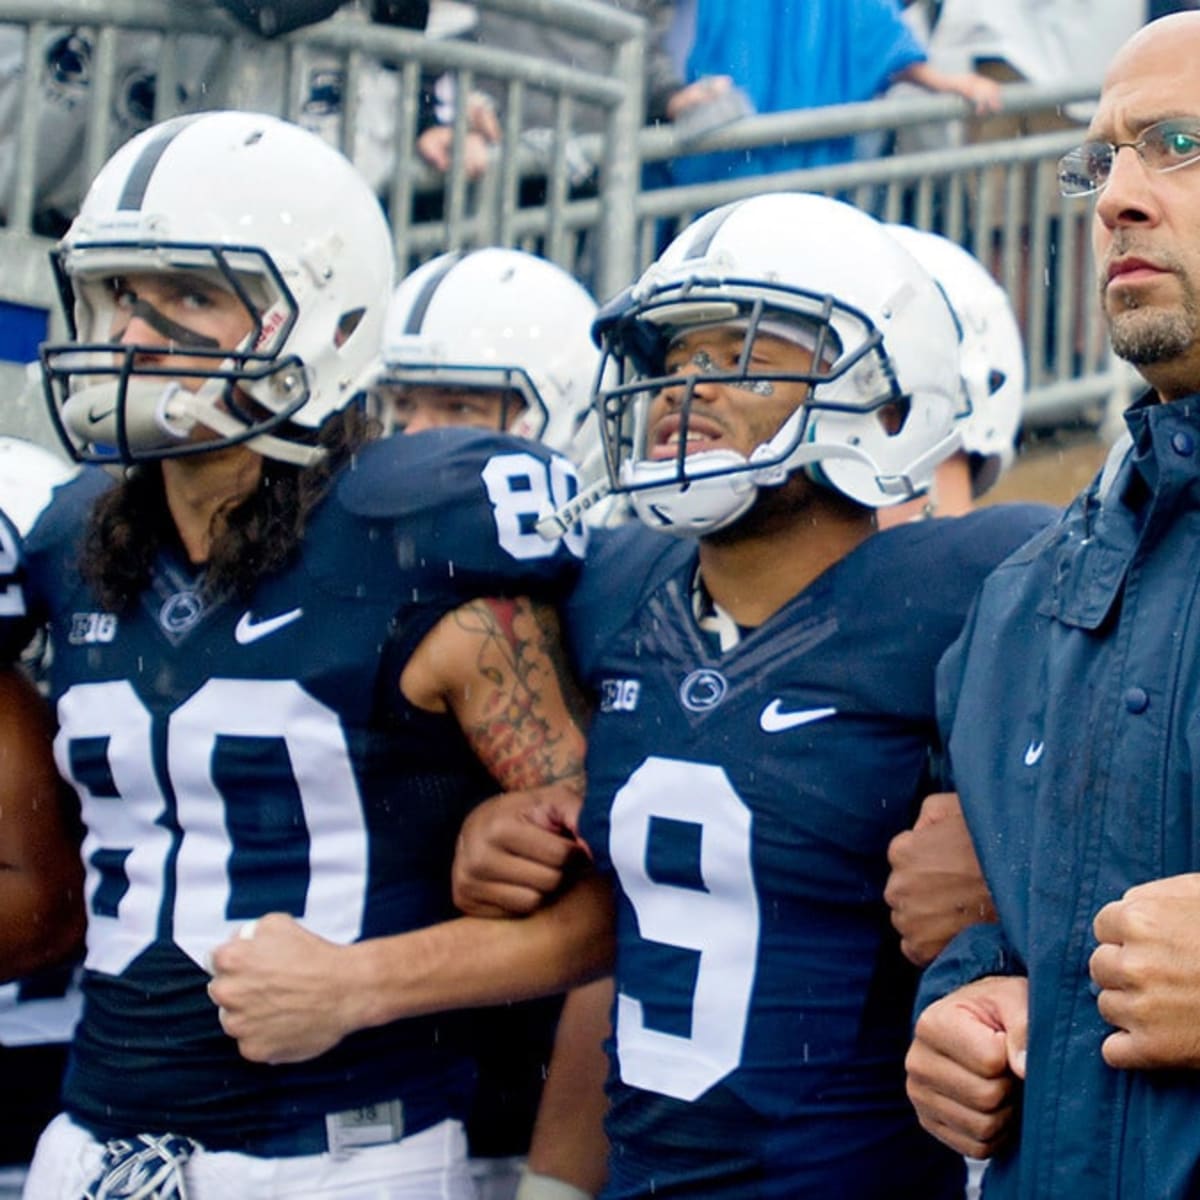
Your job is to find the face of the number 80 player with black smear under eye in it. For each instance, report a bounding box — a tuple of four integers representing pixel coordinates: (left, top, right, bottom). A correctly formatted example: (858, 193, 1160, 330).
(108, 271, 254, 390)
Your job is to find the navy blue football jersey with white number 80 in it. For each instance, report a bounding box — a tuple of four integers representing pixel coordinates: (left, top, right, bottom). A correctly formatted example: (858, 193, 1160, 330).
(0, 430, 583, 1153)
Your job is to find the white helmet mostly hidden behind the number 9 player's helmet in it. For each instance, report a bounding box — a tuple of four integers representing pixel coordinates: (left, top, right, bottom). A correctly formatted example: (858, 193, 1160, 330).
(888, 224, 1025, 496)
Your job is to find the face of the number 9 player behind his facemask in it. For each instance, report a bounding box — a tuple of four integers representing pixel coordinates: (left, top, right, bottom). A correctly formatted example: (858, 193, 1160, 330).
(647, 326, 812, 458)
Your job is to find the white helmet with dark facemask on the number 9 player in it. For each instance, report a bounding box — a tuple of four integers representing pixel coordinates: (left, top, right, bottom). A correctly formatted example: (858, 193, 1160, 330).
(595, 192, 959, 534)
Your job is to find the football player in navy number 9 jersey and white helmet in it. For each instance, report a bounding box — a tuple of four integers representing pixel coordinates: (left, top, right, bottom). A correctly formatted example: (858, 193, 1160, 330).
(456, 193, 1048, 1200)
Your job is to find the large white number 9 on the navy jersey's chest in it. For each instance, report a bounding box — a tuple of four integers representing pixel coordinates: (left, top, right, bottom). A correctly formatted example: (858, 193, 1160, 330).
(608, 757, 760, 1100)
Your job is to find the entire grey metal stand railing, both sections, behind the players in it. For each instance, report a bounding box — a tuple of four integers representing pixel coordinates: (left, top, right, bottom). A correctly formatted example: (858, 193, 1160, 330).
(0, 0, 1118, 441)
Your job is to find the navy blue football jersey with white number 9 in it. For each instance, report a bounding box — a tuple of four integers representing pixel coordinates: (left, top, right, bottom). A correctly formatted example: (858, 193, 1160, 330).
(570, 508, 1049, 1200)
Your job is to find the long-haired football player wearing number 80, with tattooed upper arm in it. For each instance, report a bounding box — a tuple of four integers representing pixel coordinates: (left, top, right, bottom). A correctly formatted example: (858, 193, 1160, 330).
(0, 113, 606, 1200)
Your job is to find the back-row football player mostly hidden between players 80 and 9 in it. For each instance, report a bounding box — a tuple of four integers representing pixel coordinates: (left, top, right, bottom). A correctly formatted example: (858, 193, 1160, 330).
(376, 246, 613, 1200)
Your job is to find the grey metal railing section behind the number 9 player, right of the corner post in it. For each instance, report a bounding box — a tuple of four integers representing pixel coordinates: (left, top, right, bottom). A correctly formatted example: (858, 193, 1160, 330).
(619, 84, 1124, 425)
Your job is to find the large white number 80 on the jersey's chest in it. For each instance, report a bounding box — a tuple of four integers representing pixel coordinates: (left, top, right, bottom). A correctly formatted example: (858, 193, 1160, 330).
(54, 679, 367, 974)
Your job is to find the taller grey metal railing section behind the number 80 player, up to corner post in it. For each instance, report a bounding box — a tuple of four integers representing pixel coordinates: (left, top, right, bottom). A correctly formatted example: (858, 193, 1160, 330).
(0, 0, 644, 424)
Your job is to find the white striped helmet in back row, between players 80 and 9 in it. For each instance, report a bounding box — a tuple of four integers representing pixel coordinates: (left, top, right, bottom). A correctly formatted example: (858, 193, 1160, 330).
(379, 246, 600, 472)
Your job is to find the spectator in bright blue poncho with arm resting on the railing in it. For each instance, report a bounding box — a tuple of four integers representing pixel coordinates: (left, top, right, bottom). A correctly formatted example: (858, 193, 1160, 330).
(674, 0, 1000, 184)
